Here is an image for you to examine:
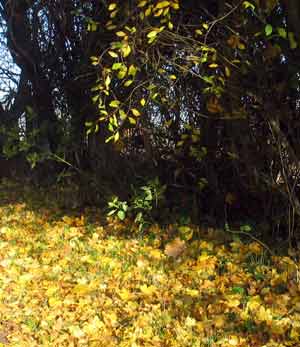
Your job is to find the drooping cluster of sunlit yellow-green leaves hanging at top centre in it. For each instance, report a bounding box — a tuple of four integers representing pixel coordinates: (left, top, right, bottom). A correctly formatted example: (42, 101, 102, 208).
(86, 0, 180, 143)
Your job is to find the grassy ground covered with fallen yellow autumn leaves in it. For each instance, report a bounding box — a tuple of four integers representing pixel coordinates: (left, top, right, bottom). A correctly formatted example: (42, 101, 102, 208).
(0, 184, 300, 347)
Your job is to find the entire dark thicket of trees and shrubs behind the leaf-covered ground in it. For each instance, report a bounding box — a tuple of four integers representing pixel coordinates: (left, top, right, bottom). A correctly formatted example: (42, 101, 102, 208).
(0, 0, 300, 245)
